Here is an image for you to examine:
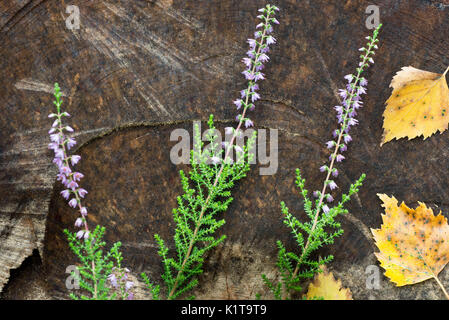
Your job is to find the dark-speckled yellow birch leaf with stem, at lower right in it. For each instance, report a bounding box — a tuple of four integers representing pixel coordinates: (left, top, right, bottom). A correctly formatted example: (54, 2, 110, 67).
(371, 194, 449, 294)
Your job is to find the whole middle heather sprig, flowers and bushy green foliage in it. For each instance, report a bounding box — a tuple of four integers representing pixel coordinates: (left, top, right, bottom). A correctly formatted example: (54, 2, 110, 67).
(142, 5, 279, 299)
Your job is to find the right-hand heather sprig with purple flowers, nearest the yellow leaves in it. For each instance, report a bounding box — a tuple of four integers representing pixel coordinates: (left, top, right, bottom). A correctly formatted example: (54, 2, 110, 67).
(262, 25, 381, 299)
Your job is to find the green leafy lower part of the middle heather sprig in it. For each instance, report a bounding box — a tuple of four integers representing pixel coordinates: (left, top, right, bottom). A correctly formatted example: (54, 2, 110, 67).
(142, 115, 256, 299)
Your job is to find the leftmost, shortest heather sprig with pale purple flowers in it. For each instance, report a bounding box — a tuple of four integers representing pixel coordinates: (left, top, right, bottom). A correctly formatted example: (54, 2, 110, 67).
(48, 83, 133, 300)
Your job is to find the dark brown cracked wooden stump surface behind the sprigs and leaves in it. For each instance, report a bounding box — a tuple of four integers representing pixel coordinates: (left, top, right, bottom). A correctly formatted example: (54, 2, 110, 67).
(0, 0, 449, 299)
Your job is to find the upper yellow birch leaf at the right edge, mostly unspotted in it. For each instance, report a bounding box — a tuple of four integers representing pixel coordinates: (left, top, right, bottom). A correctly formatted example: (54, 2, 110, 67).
(381, 67, 449, 145)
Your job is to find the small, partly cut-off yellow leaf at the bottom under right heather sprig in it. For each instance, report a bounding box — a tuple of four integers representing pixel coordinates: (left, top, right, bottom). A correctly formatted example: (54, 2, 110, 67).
(306, 266, 352, 300)
